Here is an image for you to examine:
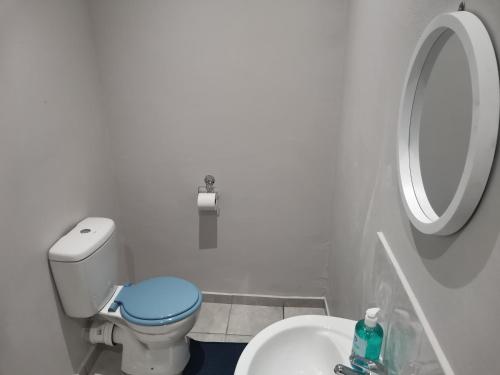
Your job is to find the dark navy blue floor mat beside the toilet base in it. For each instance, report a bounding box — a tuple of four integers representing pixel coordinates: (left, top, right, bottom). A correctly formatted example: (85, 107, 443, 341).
(183, 339, 247, 375)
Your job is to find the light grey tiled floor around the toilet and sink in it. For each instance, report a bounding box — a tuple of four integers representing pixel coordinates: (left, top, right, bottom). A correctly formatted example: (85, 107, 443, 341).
(91, 302, 325, 375)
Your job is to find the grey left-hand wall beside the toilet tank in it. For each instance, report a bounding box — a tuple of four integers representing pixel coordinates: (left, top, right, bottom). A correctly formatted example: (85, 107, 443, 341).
(0, 0, 113, 375)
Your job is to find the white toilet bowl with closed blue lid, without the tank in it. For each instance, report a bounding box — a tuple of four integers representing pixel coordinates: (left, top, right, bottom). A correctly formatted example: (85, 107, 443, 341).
(94, 277, 202, 375)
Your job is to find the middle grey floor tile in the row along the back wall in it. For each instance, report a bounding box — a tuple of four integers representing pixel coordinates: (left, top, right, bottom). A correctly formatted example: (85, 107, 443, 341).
(227, 305, 283, 336)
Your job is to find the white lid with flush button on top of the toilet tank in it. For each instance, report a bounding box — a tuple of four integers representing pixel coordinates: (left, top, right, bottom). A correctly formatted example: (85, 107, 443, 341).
(49, 217, 115, 262)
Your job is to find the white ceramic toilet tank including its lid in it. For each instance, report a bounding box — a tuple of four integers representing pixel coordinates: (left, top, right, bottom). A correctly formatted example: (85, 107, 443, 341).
(49, 217, 119, 318)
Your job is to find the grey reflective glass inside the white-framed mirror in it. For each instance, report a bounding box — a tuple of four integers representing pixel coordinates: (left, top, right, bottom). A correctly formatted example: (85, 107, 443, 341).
(412, 32, 472, 216)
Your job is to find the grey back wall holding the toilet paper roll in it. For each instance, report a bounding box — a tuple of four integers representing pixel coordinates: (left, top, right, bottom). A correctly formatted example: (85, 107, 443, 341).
(91, 0, 346, 296)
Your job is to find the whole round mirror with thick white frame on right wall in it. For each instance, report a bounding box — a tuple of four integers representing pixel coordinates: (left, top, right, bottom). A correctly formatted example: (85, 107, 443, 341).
(398, 12, 500, 235)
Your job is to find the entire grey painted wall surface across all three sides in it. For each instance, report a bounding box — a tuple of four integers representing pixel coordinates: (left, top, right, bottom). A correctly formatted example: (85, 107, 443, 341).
(0, 0, 500, 374)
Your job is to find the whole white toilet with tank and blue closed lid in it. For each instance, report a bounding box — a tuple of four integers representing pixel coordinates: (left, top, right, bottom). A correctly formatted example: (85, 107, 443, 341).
(49, 217, 202, 375)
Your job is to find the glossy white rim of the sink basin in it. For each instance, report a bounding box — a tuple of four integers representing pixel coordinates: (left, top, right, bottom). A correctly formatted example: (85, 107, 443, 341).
(234, 315, 356, 375)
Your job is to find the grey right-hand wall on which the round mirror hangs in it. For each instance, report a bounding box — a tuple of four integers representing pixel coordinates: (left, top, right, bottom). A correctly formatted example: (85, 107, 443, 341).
(329, 0, 500, 374)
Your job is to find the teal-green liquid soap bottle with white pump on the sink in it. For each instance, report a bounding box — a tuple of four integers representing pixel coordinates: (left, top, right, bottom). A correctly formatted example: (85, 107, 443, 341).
(352, 307, 384, 361)
